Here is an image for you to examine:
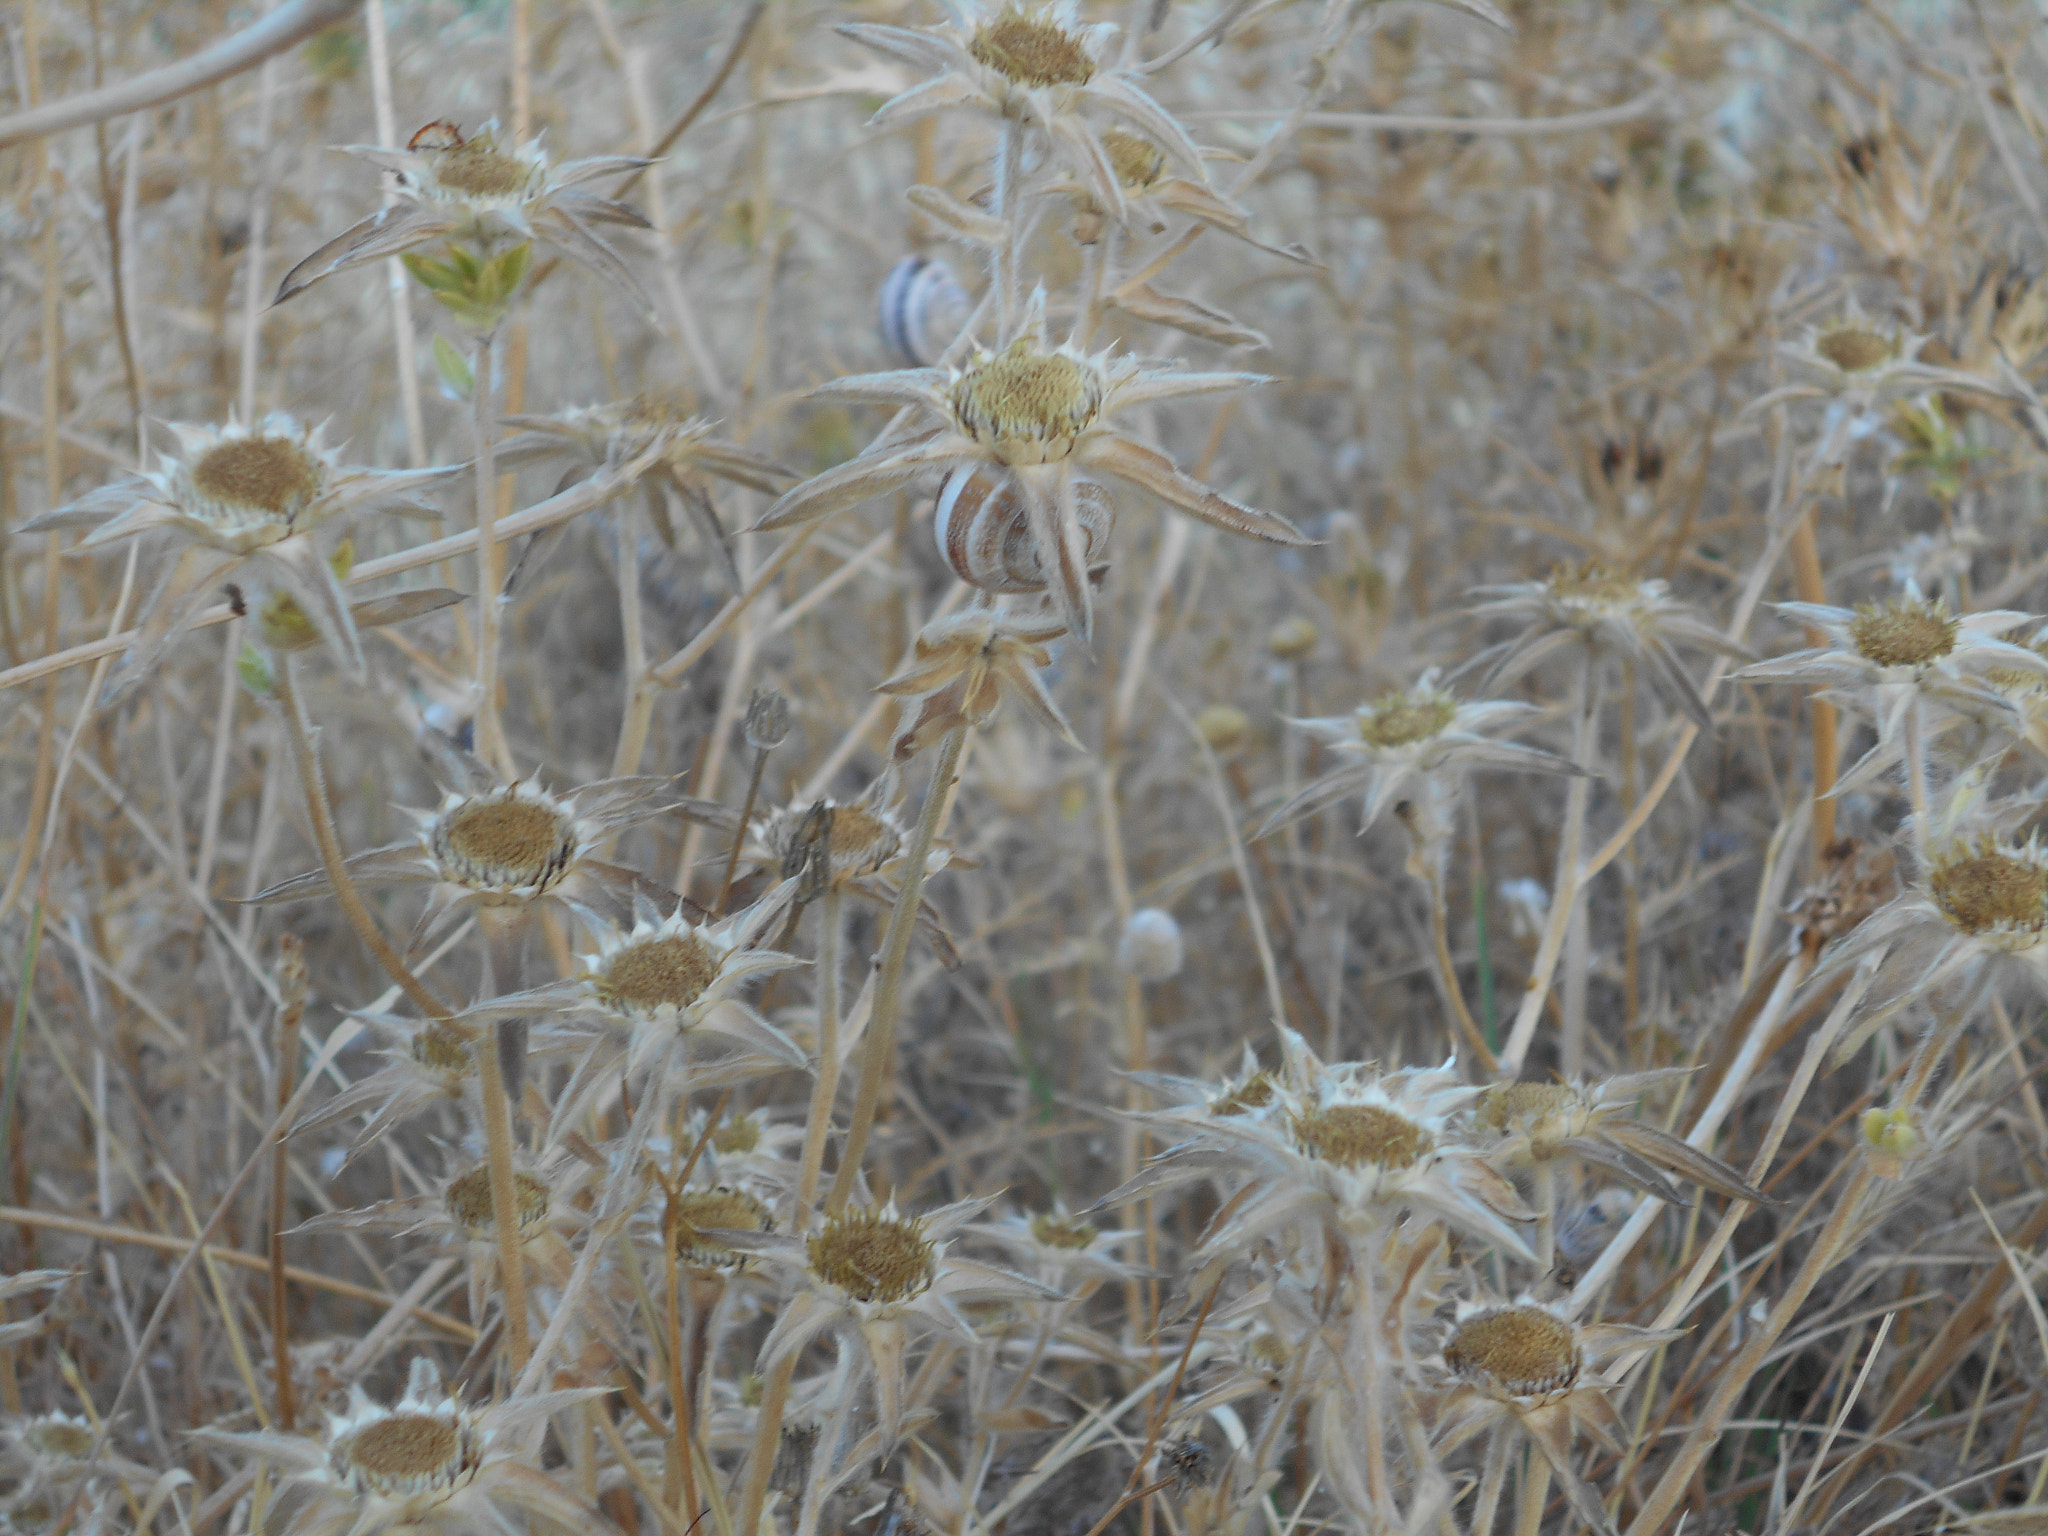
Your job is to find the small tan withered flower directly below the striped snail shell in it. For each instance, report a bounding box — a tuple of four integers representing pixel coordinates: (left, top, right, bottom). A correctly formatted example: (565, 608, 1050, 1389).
(874, 606, 1081, 762)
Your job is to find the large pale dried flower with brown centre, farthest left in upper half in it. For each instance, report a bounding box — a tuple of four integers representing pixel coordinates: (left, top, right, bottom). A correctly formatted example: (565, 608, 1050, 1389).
(16, 412, 457, 702)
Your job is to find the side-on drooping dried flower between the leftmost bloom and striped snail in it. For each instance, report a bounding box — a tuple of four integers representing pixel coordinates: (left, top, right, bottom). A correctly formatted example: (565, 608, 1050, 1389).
(498, 391, 795, 592)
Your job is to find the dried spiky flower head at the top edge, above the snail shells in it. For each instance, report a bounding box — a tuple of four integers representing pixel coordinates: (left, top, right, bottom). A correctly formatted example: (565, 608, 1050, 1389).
(840, 0, 1208, 219)
